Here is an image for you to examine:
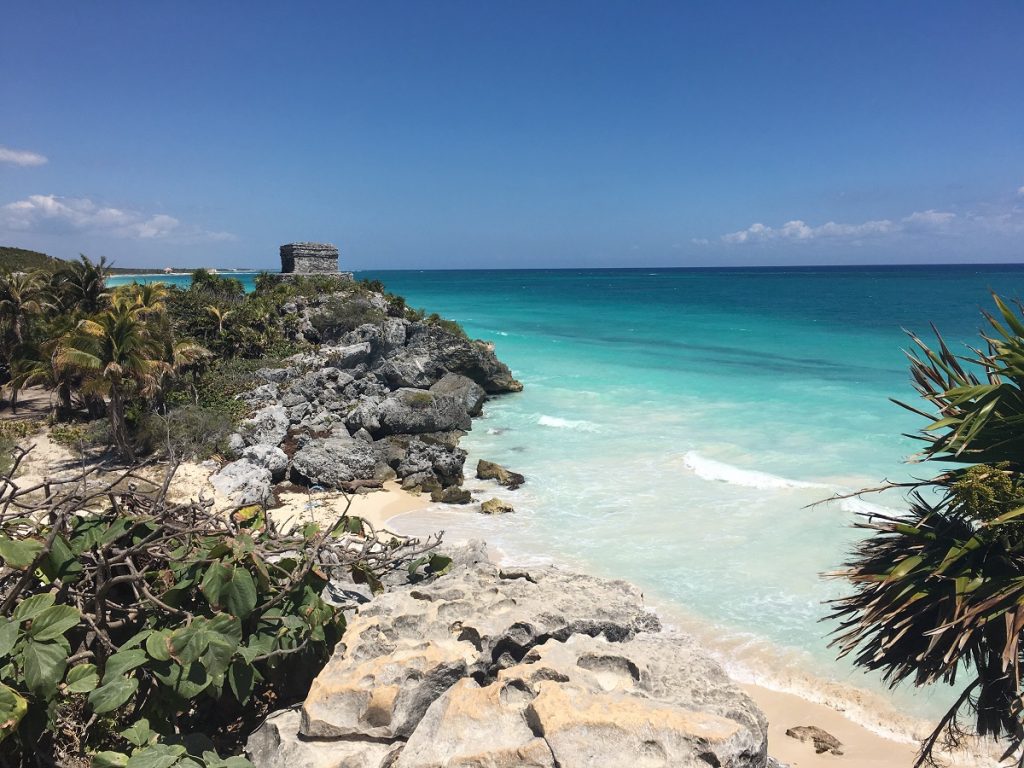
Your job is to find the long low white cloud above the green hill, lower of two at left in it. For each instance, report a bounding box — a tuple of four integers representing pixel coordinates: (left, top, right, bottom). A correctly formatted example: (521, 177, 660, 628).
(0, 195, 234, 241)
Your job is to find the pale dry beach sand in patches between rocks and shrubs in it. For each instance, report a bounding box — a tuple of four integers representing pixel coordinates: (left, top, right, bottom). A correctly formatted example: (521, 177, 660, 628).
(4, 433, 994, 768)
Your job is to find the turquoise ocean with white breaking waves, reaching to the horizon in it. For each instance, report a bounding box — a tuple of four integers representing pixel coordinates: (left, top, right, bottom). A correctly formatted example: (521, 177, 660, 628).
(110, 266, 1024, 729)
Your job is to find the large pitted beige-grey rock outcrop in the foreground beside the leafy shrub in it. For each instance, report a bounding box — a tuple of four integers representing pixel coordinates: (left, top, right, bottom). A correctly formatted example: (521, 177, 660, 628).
(247, 544, 768, 768)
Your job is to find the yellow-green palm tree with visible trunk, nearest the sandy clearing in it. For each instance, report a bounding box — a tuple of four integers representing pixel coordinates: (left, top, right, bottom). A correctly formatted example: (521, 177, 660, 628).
(57, 299, 167, 461)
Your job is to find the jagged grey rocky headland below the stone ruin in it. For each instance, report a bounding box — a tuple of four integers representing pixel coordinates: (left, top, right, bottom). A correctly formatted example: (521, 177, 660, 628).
(212, 290, 522, 503)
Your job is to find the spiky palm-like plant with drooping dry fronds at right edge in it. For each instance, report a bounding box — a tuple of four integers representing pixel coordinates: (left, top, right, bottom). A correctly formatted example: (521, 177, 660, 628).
(833, 297, 1024, 765)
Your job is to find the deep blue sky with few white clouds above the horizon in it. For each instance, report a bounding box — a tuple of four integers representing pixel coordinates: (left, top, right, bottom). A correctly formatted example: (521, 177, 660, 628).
(0, 0, 1024, 269)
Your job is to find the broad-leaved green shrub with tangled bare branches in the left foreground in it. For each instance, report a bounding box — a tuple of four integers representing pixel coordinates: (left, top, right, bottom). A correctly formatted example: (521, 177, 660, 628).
(0, 452, 451, 768)
